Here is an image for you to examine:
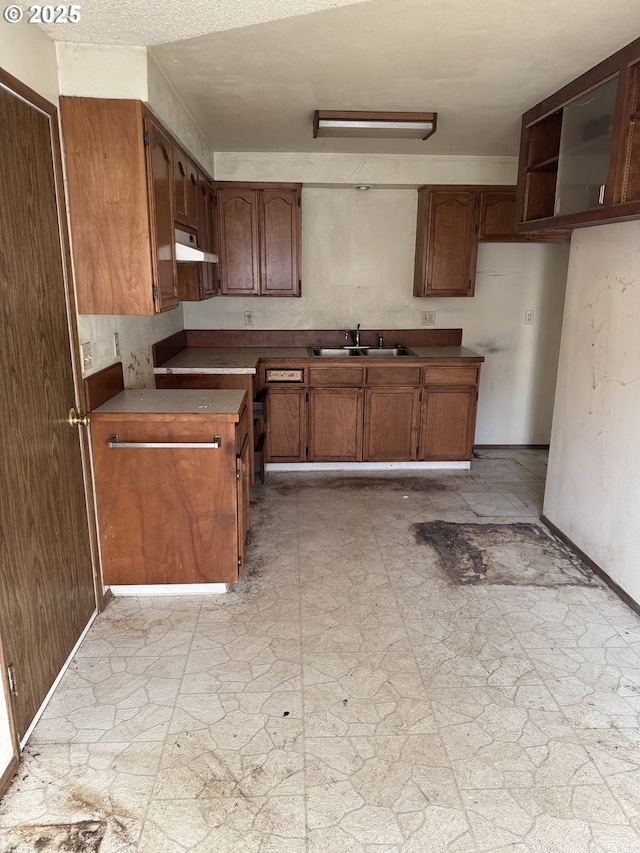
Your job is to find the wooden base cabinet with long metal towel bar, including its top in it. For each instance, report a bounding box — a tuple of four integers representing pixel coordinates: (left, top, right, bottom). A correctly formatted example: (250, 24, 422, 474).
(90, 389, 251, 586)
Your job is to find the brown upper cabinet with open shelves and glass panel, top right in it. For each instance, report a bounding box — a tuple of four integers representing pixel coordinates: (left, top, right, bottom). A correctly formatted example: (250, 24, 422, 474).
(517, 39, 640, 233)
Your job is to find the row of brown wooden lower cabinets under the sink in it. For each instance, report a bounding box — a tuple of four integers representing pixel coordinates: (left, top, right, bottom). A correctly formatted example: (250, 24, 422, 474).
(264, 359, 480, 462)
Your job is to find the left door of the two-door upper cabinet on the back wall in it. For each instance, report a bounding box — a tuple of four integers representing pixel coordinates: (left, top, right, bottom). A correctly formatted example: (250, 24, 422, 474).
(218, 187, 260, 296)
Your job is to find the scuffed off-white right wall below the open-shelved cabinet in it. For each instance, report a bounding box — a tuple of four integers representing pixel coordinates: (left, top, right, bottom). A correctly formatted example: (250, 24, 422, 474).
(544, 222, 640, 603)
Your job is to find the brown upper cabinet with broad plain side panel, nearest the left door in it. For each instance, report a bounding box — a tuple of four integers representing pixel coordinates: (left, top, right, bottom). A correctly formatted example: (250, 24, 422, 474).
(60, 97, 206, 314)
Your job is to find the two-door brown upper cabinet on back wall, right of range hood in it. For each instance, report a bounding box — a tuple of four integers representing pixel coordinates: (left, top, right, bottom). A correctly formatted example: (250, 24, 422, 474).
(216, 183, 301, 296)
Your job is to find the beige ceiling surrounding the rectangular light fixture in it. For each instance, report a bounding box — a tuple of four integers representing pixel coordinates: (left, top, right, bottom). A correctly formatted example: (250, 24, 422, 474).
(36, 0, 640, 155)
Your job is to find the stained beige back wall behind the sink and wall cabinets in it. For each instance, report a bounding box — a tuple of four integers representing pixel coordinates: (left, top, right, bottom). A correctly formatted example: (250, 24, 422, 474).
(183, 172, 569, 444)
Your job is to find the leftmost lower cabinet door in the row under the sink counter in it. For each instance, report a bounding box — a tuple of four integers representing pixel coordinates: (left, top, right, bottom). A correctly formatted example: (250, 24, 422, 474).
(266, 388, 307, 462)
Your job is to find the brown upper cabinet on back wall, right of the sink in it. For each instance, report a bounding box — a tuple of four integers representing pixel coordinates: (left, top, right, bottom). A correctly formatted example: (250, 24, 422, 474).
(413, 184, 571, 296)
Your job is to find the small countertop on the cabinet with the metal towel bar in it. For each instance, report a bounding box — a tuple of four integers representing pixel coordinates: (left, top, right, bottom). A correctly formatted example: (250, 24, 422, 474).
(90, 388, 246, 419)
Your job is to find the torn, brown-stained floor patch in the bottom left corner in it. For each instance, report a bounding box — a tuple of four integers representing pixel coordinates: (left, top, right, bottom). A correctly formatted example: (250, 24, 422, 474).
(2, 820, 107, 853)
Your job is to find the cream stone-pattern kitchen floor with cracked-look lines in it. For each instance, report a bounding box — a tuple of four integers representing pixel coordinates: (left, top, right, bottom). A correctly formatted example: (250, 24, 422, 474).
(0, 448, 640, 853)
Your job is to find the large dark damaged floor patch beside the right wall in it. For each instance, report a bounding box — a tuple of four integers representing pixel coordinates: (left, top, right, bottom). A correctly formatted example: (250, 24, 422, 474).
(413, 521, 602, 587)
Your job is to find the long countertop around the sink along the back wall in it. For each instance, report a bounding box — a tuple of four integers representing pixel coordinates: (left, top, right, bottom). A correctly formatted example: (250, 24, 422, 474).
(154, 347, 484, 374)
